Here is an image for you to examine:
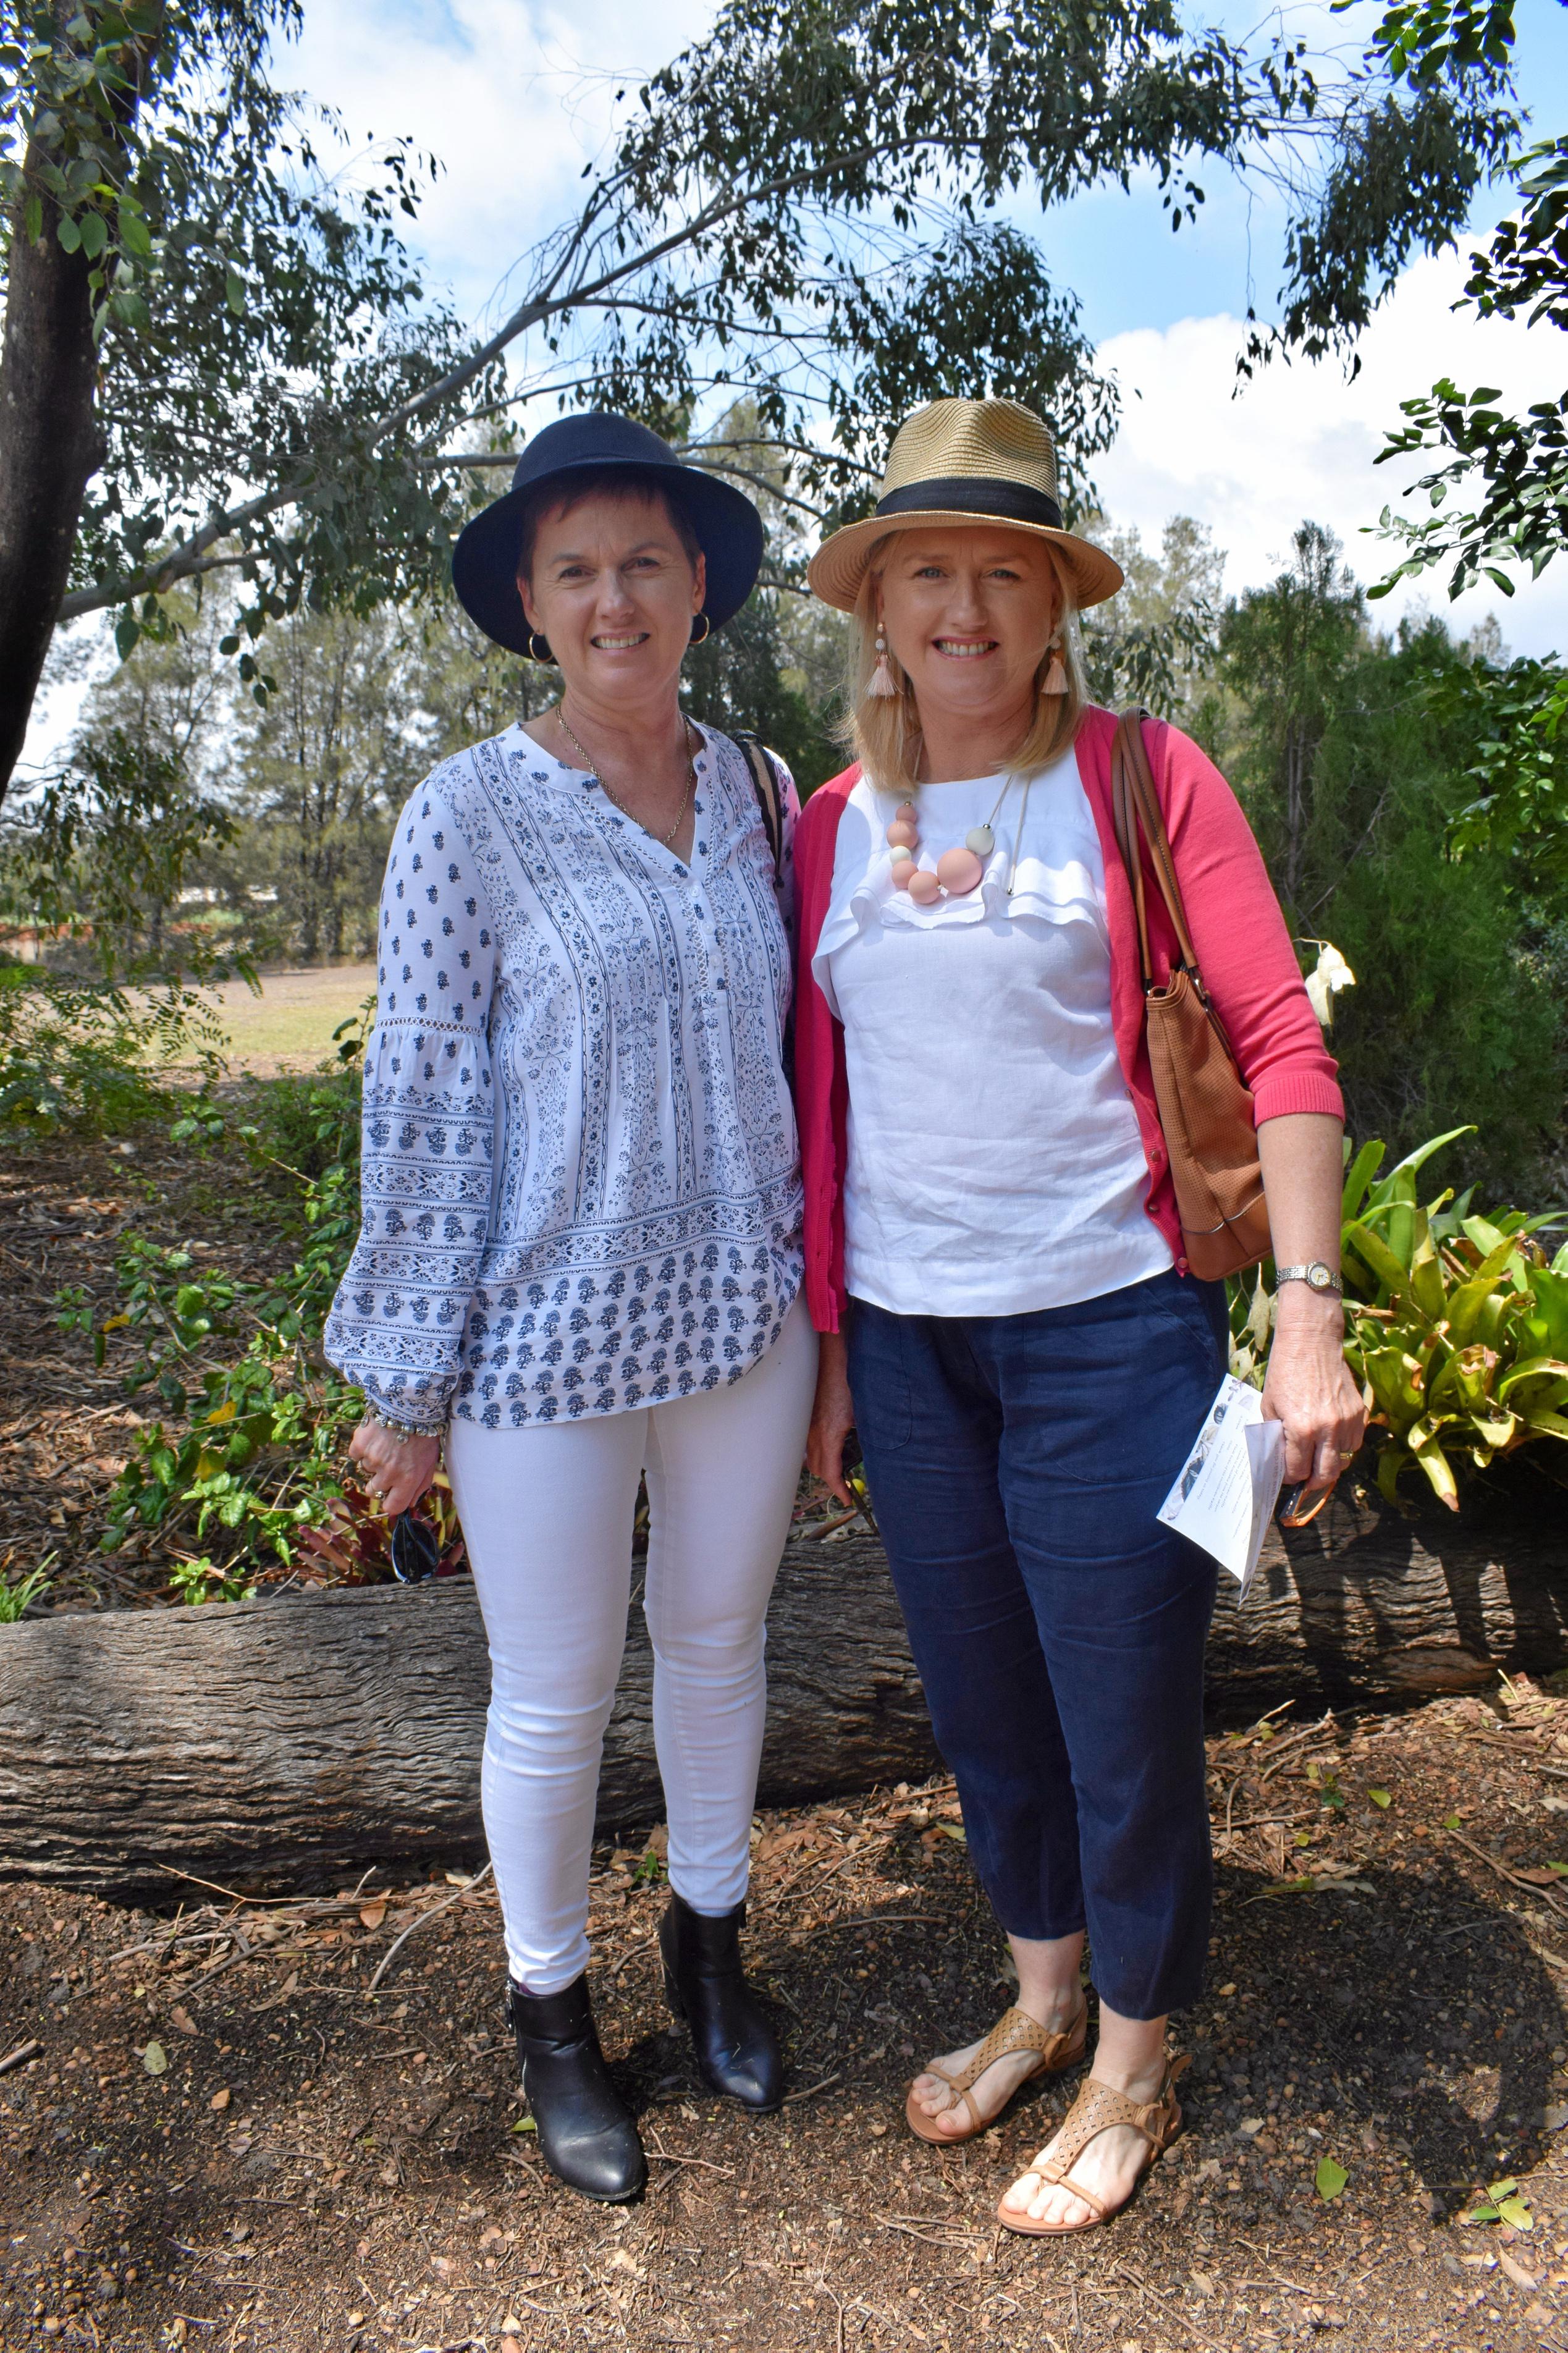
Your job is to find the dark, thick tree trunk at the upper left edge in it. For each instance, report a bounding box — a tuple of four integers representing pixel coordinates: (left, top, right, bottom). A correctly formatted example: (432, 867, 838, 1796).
(0, 148, 104, 800)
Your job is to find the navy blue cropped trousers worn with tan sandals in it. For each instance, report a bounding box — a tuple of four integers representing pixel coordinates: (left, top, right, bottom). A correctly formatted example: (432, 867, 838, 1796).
(850, 1273, 1226, 2019)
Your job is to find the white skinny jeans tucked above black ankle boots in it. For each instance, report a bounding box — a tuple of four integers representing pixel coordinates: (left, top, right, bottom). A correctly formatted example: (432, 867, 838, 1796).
(436, 1299, 817, 1993)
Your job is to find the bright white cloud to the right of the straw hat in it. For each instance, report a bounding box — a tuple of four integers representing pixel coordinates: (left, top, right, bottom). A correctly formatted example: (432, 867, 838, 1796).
(1095, 254, 1568, 654)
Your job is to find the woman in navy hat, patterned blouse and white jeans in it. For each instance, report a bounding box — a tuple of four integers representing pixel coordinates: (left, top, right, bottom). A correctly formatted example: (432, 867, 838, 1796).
(315, 414, 817, 2200)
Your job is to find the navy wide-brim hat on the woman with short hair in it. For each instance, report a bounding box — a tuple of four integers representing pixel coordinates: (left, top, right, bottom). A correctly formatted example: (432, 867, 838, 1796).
(452, 410, 763, 654)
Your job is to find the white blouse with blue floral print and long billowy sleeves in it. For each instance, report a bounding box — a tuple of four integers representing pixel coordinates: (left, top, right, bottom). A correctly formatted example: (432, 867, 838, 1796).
(325, 727, 801, 1428)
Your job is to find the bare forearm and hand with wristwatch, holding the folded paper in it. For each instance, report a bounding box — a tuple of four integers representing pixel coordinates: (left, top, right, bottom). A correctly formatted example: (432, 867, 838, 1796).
(1257, 1110, 1365, 1487)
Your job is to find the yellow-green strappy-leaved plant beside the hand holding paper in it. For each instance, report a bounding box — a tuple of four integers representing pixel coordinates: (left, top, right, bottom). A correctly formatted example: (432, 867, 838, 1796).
(1231, 1127, 1568, 1511)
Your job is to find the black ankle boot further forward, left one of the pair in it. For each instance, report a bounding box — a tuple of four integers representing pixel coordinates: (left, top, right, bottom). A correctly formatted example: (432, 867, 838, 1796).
(511, 1977, 647, 2205)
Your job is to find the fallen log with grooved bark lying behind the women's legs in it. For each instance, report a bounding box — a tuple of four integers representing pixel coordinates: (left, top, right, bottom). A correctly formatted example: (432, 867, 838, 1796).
(0, 1482, 1568, 1899)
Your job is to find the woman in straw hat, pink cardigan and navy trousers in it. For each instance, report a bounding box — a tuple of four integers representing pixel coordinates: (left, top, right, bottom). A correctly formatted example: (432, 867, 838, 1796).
(796, 400, 1361, 2233)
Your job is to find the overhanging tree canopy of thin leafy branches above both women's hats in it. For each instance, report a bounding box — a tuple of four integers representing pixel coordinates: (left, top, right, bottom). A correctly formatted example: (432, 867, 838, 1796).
(0, 0, 1519, 800)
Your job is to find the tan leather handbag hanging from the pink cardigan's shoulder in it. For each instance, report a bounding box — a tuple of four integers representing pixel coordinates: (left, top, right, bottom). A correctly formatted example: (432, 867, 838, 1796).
(1111, 711, 1269, 1280)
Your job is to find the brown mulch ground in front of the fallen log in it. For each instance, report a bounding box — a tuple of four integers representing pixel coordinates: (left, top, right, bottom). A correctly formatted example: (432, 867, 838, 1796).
(0, 1685, 1568, 2353)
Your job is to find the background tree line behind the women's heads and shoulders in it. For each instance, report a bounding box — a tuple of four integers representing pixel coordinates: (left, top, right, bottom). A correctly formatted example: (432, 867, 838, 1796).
(0, 496, 1568, 1200)
